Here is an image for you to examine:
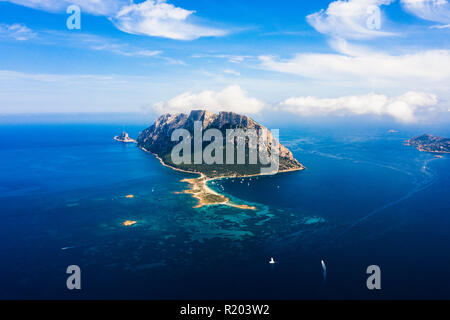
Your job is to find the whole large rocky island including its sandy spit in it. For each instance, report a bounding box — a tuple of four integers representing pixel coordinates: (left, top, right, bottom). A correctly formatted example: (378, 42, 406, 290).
(137, 110, 305, 210)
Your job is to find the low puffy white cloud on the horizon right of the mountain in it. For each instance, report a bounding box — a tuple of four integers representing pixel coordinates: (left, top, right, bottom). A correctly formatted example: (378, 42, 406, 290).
(278, 91, 438, 122)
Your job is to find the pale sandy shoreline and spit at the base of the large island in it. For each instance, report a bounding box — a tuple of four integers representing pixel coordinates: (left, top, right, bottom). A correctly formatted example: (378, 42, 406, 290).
(138, 146, 306, 210)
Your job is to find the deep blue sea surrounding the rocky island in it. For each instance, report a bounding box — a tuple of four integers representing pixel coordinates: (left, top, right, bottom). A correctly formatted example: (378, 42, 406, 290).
(0, 124, 450, 299)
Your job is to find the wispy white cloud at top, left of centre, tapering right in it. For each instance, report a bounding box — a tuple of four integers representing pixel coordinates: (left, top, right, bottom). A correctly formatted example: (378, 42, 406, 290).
(111, 0, 228, 40)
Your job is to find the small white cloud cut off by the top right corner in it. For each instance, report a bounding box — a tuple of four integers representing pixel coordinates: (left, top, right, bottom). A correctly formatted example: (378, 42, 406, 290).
(402, 0, 450, 24)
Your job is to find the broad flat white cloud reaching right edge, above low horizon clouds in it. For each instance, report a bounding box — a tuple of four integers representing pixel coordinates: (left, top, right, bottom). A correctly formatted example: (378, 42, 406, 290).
(259, 50, 450, 85)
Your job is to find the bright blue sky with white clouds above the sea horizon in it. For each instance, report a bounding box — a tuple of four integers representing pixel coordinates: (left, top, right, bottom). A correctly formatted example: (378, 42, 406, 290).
(0, 0, 450, 123)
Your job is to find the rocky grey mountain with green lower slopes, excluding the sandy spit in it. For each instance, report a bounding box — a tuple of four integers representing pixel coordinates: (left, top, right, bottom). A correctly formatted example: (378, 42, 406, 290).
(137, 110, 304, 177)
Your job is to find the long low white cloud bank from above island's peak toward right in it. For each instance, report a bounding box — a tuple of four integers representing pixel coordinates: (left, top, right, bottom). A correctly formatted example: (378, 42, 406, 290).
(152, 85, 446, 123)
